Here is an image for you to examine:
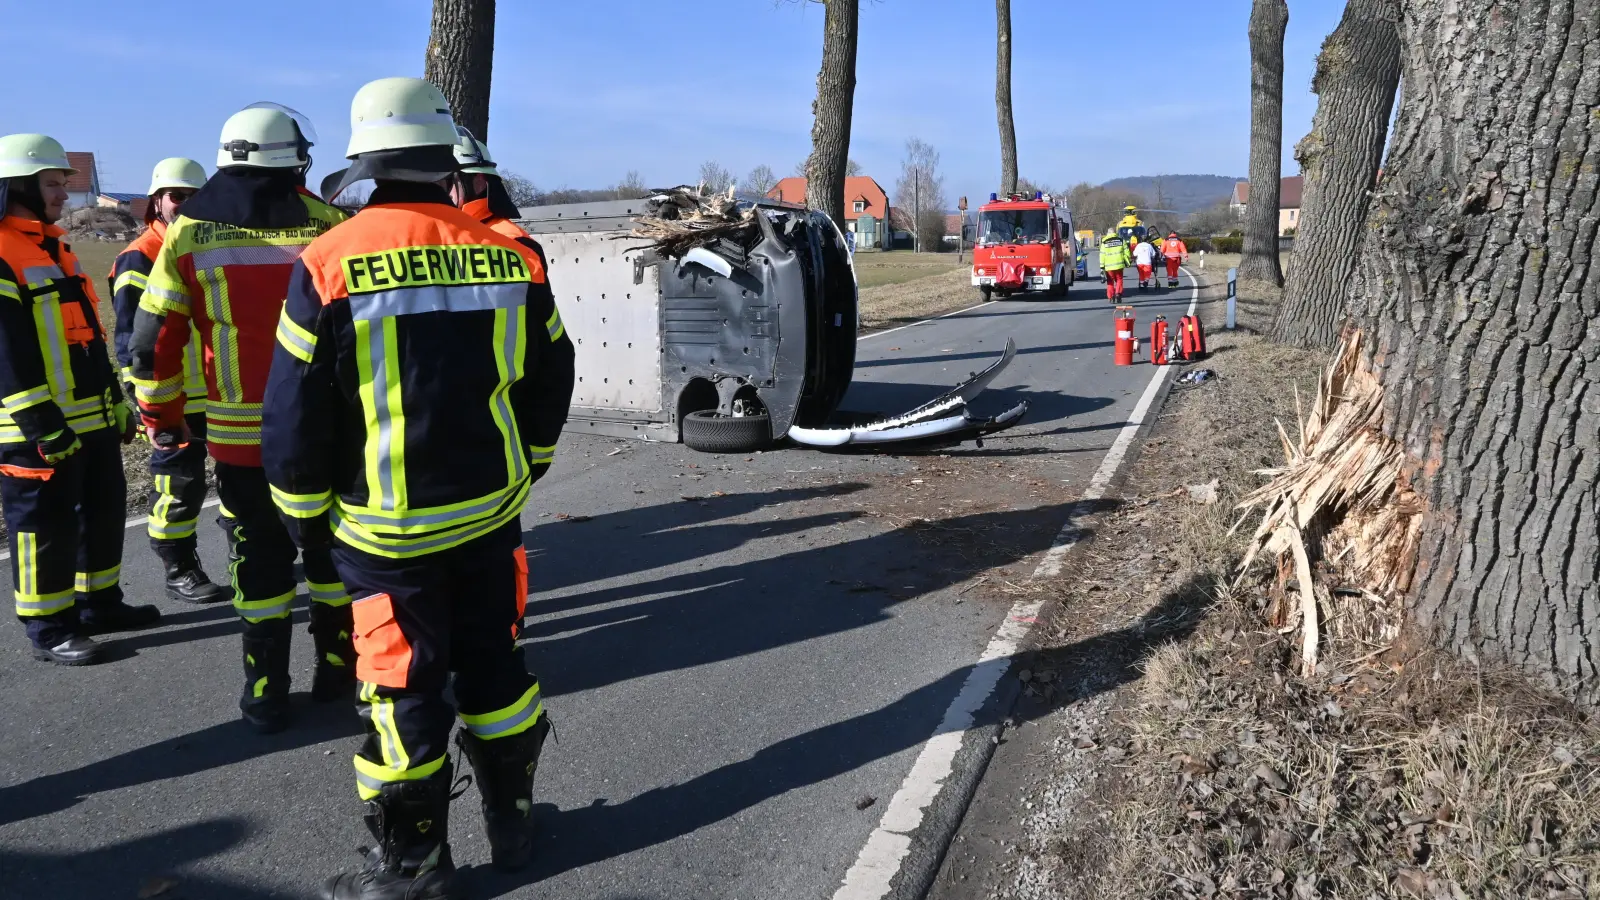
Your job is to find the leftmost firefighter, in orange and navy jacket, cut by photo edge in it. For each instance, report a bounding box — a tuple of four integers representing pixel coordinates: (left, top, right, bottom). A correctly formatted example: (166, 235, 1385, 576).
(0, 135, 160, 666)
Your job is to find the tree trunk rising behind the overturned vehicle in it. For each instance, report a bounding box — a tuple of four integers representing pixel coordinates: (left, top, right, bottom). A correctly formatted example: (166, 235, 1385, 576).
(805, 0, 864, 231)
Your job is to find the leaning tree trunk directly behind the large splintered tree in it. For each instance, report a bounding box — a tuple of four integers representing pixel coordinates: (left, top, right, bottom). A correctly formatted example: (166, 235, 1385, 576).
(1272, 0, 1400, 348)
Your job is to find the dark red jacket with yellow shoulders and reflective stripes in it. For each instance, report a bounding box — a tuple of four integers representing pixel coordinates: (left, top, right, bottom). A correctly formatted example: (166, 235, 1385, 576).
(130, 191, 347, 466)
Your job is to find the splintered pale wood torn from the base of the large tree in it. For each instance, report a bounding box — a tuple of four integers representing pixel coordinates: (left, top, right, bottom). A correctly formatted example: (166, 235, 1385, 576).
(1234, 331, 1422, 666)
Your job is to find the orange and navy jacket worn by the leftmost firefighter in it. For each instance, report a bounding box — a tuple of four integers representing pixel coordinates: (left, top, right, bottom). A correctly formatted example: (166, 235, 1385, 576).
(0, 216, 122, 445)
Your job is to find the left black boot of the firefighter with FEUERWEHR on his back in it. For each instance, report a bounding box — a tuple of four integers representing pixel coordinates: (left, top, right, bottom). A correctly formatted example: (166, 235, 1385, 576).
(322, 759, 456, 900)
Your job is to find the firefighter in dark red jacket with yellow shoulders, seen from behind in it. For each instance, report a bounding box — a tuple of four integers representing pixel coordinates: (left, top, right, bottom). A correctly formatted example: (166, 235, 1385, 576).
(130, 104, 355, 733)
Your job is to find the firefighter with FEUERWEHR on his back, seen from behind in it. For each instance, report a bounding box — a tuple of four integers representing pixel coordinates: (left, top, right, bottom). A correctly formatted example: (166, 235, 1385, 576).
(262, 78, 573, 900)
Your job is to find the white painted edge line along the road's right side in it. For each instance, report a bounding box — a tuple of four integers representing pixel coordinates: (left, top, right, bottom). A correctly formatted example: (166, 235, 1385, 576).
(834, 267, 1200, 900)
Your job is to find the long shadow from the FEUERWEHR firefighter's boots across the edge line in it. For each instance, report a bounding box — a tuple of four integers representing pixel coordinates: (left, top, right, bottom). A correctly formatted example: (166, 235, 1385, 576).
(464, 560, 1205, 897)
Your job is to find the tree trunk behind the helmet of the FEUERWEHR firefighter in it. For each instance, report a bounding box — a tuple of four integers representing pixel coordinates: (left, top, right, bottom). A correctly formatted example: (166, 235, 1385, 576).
(422, 0, 494, 141)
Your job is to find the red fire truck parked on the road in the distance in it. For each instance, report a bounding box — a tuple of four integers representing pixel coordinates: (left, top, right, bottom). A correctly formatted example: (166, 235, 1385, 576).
(973, 191, 1077, 299)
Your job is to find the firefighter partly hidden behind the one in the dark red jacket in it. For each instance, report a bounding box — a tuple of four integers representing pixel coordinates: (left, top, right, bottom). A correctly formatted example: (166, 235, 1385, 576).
(107, 157, 227, 604)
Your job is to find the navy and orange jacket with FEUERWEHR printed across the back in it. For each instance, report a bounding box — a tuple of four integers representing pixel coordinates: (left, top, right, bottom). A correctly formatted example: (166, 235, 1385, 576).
(261, 184, 574, 557)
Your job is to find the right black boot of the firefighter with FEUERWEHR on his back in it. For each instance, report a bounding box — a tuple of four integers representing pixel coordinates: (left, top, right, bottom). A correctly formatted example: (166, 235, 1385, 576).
(456, 714, 550, 871)
